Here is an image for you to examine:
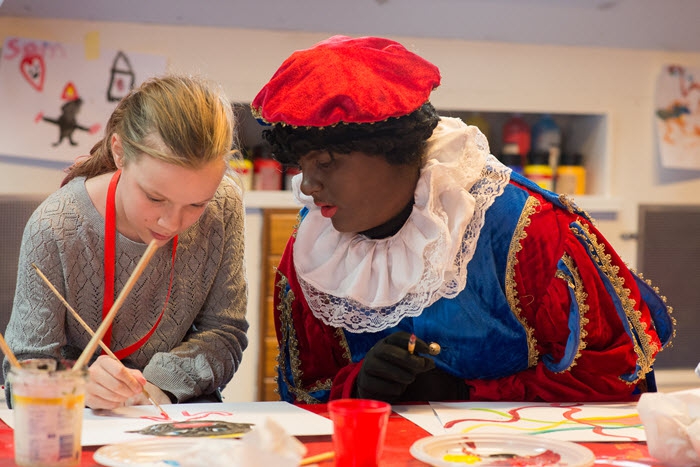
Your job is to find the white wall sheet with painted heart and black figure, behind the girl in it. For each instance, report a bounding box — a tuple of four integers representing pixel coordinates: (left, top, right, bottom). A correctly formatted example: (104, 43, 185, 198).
(0, 37, 166, 165)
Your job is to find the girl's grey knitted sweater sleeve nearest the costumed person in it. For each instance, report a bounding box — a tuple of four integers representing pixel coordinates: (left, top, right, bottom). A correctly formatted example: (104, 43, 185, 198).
(143, 179, 248, 402)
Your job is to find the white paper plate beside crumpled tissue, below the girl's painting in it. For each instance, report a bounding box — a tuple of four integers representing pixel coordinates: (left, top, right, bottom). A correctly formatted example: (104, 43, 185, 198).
(93, 437, 239, 467)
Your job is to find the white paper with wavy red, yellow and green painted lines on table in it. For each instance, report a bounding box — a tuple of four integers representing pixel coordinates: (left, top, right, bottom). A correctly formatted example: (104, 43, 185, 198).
(394, 402, 646, 442)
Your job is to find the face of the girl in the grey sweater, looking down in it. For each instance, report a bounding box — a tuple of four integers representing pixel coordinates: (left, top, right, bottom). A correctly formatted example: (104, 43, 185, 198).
(113, 134, 226, 246)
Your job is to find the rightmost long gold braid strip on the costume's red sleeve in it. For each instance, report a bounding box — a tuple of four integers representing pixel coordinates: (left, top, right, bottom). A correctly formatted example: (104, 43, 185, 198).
(570, 221, 660, 382)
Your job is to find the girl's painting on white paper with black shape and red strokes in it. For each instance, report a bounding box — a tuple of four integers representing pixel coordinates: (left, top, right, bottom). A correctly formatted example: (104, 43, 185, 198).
(0, 401, 333, 446)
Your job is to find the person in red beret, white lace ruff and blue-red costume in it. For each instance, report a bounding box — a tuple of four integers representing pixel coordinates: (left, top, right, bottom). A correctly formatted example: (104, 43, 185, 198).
(252, 36, 674, 403)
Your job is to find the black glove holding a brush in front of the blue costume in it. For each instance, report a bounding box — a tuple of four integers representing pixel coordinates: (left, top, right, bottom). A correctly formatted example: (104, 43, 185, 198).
(355, 331, 435, 403)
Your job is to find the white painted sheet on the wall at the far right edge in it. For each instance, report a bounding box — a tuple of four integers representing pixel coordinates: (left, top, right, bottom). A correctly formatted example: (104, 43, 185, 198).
(655, 65, 700, 170)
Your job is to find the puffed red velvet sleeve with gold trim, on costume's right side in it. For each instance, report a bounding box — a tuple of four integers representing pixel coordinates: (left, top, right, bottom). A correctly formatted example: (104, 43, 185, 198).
(467, 197, 661, 401)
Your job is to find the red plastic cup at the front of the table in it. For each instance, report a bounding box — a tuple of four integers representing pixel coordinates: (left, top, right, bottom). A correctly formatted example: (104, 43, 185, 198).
(328, 399, 391, 467)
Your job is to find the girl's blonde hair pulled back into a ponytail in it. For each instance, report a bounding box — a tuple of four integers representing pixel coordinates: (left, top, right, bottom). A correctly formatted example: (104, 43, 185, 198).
(62, 75, 234, 185)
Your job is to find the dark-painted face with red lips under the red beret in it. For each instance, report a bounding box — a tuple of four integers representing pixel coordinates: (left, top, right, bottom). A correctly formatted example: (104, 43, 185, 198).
(299, 151, 420, 233)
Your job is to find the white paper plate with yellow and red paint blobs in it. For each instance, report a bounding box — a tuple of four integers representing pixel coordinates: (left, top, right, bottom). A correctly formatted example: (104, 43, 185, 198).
(411, 433, 595, 467)
